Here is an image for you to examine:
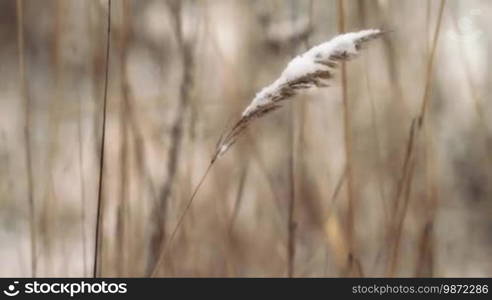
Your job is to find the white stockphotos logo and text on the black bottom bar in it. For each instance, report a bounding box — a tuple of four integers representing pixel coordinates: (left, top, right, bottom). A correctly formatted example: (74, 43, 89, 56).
(3, 280, 128, 297)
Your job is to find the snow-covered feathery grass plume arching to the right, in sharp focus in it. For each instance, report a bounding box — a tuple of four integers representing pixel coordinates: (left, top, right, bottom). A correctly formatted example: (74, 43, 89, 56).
(212, 29, 383, 161)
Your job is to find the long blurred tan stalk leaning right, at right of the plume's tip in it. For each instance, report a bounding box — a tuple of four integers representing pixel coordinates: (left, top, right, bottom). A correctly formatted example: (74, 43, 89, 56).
(386, 0, 446, 276)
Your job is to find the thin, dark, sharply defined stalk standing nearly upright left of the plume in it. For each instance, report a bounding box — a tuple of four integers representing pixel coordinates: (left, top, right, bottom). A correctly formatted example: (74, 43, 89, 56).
(93, 0, 111, 278)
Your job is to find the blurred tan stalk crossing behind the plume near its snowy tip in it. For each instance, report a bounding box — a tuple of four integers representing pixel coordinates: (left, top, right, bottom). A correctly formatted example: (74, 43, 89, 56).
(338, 0, 354, 274)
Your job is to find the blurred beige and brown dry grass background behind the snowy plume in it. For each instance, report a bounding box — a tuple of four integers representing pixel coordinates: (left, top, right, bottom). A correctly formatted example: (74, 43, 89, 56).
(0, 0, 492, 277)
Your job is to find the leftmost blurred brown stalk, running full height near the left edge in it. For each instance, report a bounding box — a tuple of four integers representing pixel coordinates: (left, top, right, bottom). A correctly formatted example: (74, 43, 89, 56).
(16, 0, 37, 277)
